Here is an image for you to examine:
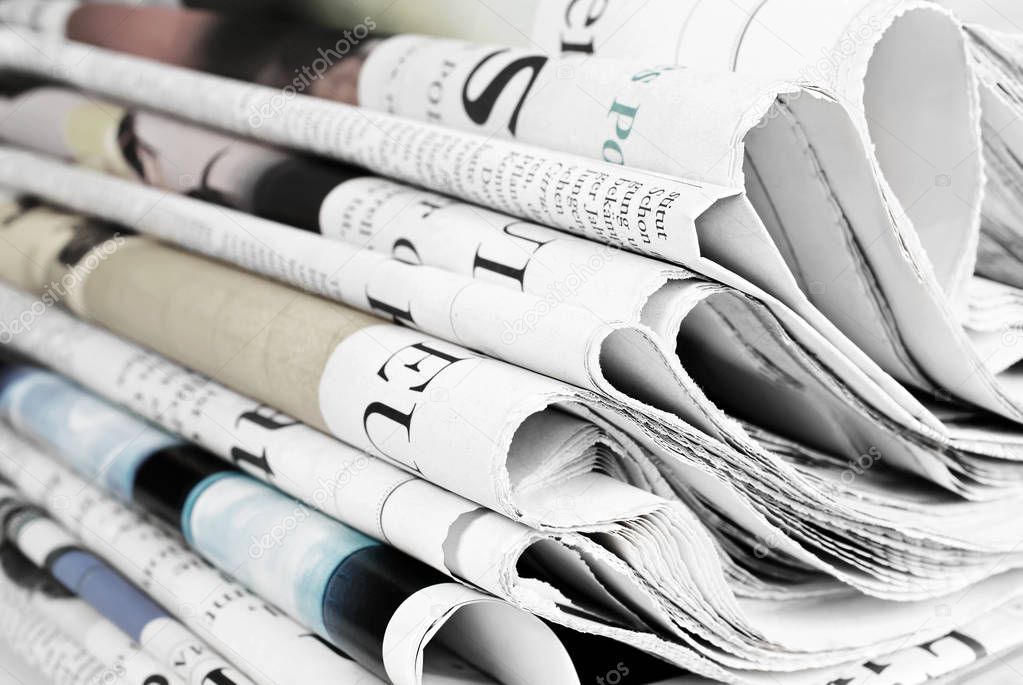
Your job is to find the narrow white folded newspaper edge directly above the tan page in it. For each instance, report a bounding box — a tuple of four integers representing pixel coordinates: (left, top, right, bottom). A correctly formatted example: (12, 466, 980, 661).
(0, 149, 605, 396)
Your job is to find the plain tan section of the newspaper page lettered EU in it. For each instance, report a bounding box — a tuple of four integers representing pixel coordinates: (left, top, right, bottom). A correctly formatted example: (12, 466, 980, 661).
(75, 238, 376, 426)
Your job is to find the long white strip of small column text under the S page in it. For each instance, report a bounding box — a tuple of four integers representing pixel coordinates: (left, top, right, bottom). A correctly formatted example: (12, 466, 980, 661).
(0, 25, 911, 413)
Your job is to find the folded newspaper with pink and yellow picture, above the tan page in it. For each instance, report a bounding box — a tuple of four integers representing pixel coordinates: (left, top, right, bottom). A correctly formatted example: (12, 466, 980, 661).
(3, 90, 949, 478)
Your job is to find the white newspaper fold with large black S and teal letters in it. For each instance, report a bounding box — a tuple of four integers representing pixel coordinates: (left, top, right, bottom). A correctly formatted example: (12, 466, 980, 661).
(349, 33, 1023, 420)
